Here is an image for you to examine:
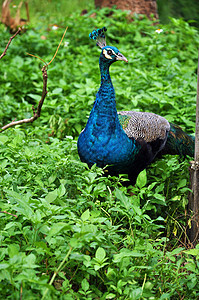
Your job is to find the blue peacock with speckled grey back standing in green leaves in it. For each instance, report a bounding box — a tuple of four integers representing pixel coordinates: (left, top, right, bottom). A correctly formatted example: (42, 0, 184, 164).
(77, 27, 195, 184)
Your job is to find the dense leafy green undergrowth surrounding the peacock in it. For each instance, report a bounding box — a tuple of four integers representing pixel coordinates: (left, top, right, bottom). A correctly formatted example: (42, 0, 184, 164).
(0, 9, 199, 300)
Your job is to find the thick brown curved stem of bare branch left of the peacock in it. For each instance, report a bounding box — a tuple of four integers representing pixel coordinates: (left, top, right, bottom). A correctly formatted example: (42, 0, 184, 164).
(0, 66, 48, 132)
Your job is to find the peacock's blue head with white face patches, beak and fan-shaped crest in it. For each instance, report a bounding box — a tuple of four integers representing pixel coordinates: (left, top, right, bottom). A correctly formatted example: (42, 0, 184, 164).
(89, 27, 128, 65)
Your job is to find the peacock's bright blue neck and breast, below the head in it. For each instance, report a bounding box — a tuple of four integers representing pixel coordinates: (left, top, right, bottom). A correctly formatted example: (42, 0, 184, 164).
(78, 56, 136, 173)
